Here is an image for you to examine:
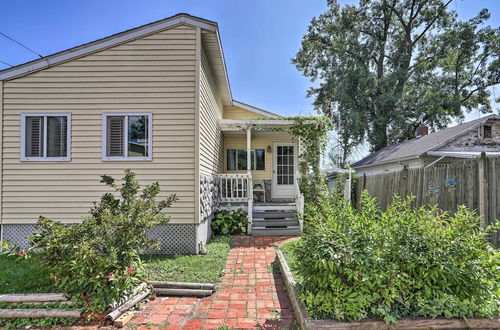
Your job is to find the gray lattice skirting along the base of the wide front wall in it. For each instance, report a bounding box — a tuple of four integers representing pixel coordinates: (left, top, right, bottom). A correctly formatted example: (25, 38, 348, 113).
(2, 219, 210, 254)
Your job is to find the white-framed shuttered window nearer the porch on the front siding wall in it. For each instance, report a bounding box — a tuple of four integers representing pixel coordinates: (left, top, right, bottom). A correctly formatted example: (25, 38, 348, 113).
(102, 113, 152, 161)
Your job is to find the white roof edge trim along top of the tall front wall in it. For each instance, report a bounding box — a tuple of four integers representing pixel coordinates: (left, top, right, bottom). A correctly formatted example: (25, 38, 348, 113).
(0, 14, 217, 84)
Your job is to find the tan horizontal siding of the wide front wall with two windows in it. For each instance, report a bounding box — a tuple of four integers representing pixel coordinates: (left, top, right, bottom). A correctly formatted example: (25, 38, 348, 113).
(2, 25, 198, 223)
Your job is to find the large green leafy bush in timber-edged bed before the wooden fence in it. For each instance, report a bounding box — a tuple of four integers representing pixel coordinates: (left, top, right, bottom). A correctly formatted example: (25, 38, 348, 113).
(294, 192, 500, 323)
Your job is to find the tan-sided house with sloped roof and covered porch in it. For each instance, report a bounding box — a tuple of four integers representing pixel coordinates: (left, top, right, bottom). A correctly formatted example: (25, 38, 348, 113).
(0, 14, 301, 253)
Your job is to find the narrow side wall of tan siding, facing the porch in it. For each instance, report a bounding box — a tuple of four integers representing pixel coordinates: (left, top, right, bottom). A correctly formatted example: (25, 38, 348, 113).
(200, 47, 223, 175)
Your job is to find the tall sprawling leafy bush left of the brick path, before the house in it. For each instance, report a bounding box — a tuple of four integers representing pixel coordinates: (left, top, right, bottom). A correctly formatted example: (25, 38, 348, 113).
(32, 170, 176, 313)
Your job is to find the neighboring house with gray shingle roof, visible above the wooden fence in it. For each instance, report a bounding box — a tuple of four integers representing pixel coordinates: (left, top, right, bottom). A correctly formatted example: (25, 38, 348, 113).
(351, 114, 500, 176)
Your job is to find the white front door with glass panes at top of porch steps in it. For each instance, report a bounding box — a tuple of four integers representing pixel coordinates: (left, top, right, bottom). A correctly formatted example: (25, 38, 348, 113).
(272, 142, 297, 199)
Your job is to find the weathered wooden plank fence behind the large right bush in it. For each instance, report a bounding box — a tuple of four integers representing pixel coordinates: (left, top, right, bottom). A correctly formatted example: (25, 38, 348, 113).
(355, 156, 500, 246)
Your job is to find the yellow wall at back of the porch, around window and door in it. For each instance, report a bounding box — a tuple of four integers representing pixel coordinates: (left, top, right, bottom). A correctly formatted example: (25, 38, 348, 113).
(224, 134, 293, 180)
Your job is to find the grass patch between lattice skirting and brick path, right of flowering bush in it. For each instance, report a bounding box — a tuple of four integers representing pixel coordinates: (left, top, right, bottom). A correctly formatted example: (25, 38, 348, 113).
(142, 236, 231, 283)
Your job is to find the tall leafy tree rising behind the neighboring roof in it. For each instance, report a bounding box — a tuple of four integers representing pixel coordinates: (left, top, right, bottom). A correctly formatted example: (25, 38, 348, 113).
(292, 0, 500, 155)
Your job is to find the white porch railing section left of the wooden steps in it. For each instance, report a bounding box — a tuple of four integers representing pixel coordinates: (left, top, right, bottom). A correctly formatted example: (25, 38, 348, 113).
(218, 173, 253, 203)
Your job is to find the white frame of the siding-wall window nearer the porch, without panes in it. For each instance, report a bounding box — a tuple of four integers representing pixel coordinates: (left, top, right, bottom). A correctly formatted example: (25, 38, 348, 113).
(101, 112, 153, 162)
